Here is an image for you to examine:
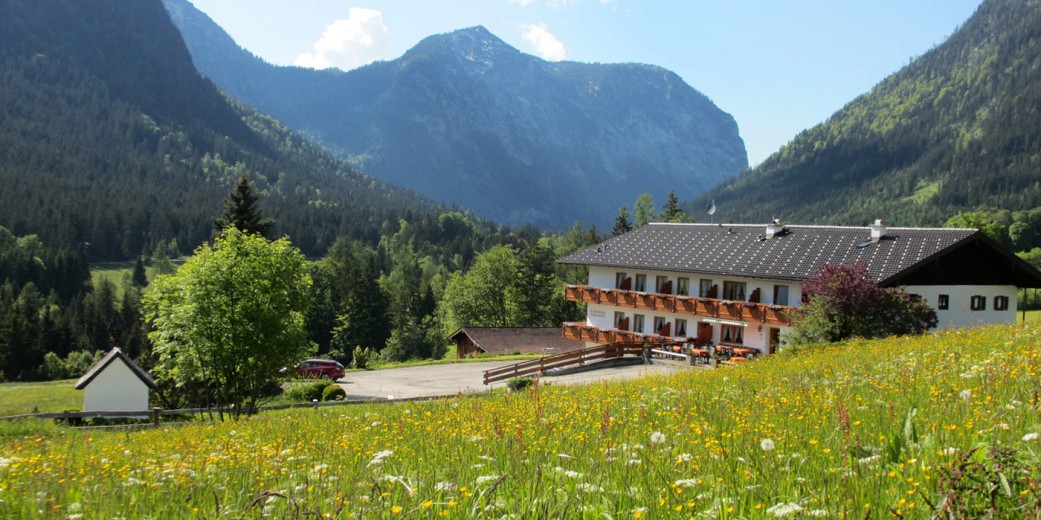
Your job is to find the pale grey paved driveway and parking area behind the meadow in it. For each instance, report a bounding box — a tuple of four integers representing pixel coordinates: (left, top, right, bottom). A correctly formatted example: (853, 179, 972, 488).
(338, 361, 689, 399)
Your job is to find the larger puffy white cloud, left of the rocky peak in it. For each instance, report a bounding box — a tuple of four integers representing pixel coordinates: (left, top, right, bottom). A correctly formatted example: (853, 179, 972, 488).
(295, 7, 390, 71)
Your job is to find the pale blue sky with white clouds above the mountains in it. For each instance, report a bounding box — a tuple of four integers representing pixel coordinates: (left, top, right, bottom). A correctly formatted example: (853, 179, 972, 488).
(192, 0, 980, 165)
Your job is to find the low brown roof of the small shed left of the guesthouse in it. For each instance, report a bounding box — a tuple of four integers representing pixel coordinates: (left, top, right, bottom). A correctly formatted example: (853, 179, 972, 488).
(449, 327, 585, 356)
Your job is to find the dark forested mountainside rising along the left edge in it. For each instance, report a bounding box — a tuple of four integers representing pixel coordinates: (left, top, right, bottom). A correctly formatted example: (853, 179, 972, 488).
(0, 0, 436, 259)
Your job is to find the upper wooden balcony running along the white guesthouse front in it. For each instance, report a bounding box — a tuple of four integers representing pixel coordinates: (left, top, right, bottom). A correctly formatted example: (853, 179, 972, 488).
(564, 285, 796, 326)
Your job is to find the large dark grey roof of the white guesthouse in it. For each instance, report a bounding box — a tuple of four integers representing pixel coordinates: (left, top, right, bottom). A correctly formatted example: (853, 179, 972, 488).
(559, 223, 1041, 287)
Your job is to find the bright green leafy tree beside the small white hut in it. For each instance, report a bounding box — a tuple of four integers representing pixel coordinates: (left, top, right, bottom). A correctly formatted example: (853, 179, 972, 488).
(145, 227, 311, 418)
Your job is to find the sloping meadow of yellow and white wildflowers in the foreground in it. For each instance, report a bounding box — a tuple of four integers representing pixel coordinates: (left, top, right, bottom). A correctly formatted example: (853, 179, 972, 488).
(0, 326, 1041, 519)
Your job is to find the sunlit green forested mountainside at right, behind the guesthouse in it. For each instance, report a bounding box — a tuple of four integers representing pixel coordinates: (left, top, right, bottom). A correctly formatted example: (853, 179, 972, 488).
(691, 0, 1041, 226)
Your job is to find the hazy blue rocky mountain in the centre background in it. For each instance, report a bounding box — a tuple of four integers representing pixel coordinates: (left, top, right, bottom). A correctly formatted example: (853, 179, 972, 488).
(164, 0, 747, 228)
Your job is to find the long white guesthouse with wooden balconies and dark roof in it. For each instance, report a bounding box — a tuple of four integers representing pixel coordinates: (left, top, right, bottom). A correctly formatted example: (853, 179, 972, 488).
(560, 222, 1041, 354)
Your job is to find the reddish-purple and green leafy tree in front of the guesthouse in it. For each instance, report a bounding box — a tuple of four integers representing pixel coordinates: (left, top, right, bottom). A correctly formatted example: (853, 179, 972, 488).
(787, 263, 937, 344)
